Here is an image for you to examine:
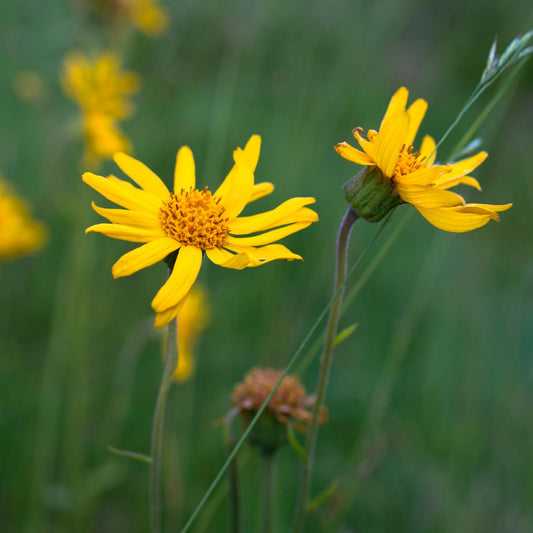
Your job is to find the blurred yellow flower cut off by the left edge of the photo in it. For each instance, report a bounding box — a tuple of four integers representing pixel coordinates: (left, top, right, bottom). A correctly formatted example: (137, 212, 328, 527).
(0, 176, 46, 260)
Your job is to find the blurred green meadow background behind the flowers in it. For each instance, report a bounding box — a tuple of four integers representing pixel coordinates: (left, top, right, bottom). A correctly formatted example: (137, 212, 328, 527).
(0, 0, 533, 533)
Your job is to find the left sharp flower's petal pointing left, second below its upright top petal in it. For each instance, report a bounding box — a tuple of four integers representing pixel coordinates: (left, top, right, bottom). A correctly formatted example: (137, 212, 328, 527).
(82, 172, 161, 213)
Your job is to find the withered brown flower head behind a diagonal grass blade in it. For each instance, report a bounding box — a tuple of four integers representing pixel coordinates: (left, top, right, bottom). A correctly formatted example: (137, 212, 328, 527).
(231, 367, 328, 431)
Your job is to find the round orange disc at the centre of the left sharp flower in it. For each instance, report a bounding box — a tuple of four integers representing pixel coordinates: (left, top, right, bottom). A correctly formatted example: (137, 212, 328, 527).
(159, 187, 229, 250)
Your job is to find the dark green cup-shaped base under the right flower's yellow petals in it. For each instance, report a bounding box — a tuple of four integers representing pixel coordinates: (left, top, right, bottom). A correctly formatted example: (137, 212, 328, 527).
(343, 166, 405, 222)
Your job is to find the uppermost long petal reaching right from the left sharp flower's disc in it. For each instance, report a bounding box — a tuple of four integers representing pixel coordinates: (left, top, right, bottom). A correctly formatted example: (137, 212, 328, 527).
(229, 197, 318, 235)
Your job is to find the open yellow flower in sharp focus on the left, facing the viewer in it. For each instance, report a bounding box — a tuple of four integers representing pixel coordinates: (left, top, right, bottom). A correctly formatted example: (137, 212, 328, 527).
(83, 135, 318, 327)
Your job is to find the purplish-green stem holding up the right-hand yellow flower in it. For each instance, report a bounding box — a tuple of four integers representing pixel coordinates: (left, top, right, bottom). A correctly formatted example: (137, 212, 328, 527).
(293, 208, 359, 533)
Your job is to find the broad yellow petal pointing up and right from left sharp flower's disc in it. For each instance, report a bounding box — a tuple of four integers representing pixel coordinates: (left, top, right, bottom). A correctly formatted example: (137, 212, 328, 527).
(214, 148, 254, 220)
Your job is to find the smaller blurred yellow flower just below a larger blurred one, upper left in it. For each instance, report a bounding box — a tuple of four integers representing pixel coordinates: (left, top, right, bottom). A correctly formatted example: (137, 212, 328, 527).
(83, 112, 131, 167)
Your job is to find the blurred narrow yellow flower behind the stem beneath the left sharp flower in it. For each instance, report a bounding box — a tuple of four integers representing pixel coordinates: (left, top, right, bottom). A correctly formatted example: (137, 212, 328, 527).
(174, 288, 208, 383)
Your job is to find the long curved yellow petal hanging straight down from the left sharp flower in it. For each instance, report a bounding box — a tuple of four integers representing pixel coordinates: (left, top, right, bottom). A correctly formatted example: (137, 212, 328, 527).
(152, 246, 202, 313)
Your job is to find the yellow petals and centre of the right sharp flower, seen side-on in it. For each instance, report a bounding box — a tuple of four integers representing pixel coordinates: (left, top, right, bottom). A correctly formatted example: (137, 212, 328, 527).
(335, 87, 512, 233)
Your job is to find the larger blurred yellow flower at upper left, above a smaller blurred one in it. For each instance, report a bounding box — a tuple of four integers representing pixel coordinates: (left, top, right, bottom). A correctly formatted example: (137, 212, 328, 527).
(62, 52, 139, 119)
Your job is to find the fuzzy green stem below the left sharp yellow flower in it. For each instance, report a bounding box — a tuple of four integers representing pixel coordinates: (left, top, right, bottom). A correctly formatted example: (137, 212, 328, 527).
(149, 320, 178, 533)
